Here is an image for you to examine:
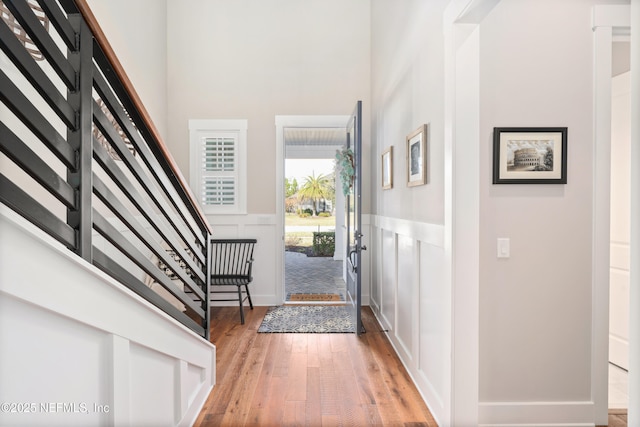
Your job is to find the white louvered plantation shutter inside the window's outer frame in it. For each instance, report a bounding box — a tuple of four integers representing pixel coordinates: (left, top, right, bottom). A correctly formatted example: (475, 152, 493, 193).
(200, 134, 238, 206)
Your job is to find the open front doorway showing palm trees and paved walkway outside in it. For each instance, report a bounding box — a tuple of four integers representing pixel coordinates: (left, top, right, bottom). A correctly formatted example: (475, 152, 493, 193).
(283, 126, 346, 304)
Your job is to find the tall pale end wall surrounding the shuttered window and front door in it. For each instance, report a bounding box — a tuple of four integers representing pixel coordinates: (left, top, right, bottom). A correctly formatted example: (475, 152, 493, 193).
(167, 0, 370, 304)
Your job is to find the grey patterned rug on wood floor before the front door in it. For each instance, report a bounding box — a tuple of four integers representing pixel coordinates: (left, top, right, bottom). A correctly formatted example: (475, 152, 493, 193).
(258, 305, 355, 334)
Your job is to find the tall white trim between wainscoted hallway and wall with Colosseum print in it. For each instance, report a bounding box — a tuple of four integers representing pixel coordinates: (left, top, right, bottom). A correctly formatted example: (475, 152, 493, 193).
(441, 0, 500, 425)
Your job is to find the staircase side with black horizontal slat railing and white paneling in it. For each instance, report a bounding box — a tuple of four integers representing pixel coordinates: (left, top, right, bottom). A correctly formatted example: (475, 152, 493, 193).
(0, 0, 215, 426)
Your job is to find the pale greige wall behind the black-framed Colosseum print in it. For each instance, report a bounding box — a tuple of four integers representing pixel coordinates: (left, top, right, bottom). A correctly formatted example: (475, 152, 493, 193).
(479, 0, 624, 424)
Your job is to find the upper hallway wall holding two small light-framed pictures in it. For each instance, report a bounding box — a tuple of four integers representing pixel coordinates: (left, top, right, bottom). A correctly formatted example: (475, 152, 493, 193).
(371, 0, 447, 224)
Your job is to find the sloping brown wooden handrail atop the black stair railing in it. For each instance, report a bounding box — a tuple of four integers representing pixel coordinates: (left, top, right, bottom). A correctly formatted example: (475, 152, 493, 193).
(75, 0, 213, 234)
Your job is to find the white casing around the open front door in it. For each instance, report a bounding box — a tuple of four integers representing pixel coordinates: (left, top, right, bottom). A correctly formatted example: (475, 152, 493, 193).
(275, 114, 351, 302)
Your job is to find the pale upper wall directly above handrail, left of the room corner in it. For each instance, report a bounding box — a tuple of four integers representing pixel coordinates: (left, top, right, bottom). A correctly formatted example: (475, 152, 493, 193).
(87, 0, 168, 142)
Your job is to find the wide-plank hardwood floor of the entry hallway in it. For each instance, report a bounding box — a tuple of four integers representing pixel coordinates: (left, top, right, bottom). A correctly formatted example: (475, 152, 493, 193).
(194, 307, 437, 427)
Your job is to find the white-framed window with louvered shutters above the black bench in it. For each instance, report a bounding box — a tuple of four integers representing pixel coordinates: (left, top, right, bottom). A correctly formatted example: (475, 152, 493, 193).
(189, 120, 247, 214)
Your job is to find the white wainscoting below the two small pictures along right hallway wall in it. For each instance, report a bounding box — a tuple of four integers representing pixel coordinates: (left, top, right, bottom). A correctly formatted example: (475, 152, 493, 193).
(370, 216, 450, 426)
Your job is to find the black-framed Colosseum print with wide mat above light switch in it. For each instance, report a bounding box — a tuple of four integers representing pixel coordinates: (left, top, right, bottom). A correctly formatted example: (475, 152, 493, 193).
(493, 128, 567, 184)
